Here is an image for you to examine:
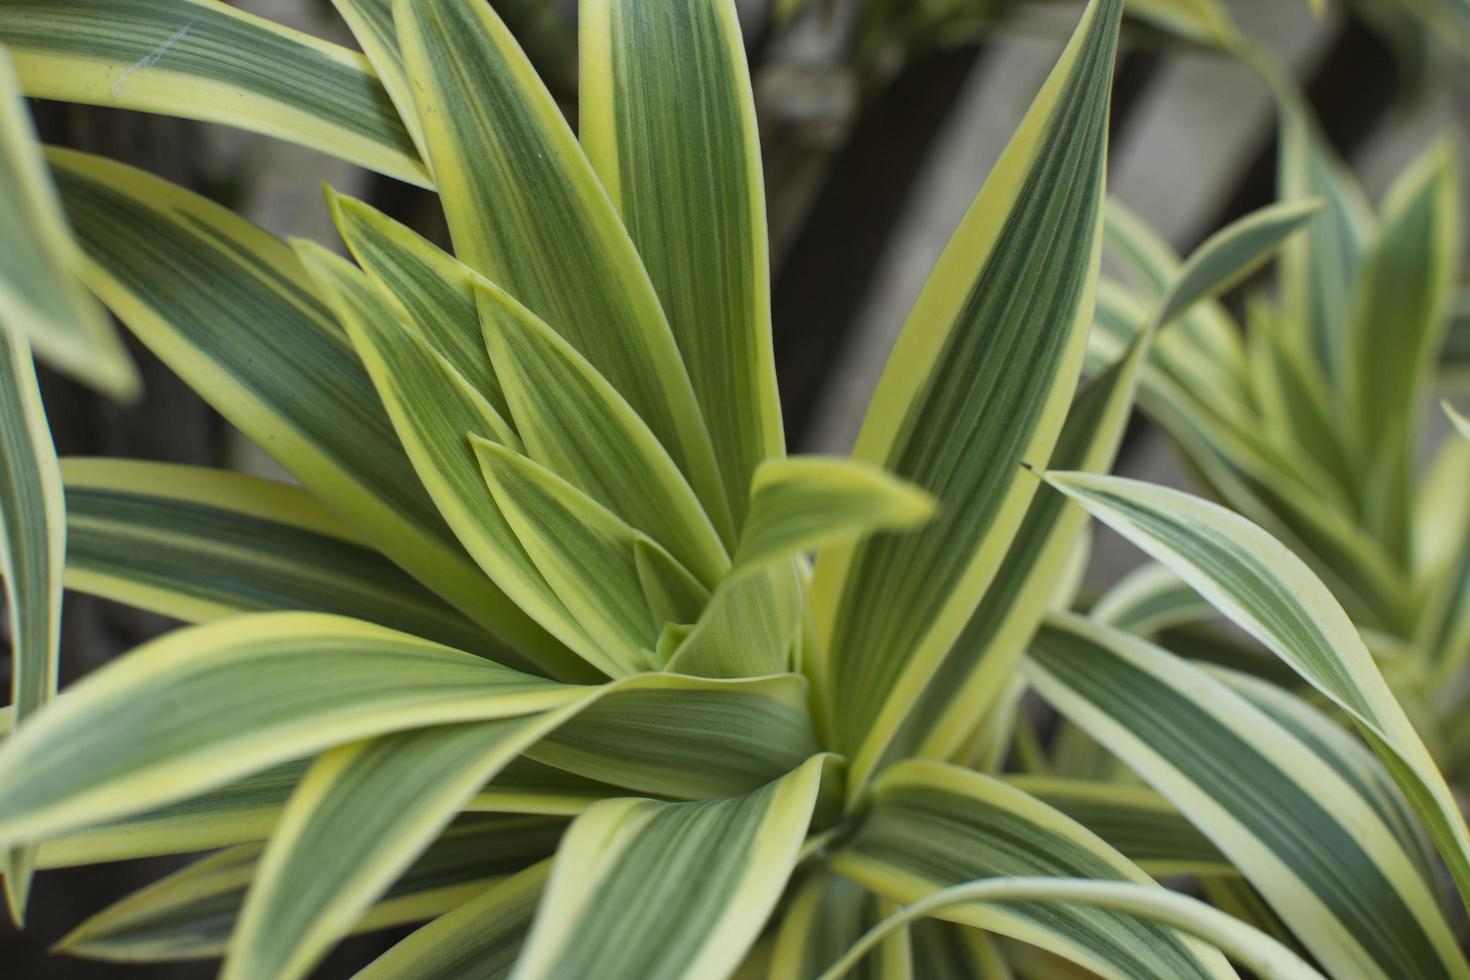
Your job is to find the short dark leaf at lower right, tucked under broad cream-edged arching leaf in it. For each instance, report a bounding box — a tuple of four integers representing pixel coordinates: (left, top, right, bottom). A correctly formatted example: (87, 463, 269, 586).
(1005, 776, 1236, 877)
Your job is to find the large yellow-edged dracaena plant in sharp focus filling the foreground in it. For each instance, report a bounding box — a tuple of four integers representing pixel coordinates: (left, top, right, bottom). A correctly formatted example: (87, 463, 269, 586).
(0, 0, 1470, 980)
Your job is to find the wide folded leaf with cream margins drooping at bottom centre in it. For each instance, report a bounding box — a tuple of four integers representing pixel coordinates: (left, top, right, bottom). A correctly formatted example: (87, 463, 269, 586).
(515, 757, 828, 980)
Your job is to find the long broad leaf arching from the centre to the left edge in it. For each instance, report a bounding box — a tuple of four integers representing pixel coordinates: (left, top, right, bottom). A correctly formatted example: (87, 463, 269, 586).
(0, 613, 578, 845)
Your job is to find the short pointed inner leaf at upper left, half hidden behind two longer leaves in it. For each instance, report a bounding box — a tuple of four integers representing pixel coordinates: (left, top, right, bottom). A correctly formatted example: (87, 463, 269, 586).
(326, 191, 515, 428)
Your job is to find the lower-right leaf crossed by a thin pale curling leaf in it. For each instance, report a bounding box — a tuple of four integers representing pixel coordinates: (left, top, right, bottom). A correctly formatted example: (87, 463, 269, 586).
(832, 761, 1233, 980)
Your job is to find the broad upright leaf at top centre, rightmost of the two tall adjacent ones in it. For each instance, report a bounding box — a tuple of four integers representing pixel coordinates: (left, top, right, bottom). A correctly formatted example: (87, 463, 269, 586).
(579, 0, 785, 526)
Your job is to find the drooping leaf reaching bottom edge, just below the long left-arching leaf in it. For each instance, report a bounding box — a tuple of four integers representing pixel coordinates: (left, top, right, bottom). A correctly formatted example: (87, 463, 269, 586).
(221, 716, 556, 980)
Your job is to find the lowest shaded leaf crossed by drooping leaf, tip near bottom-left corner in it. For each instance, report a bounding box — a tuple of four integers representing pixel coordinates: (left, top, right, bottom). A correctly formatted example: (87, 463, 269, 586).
(60, 815, 566, 962)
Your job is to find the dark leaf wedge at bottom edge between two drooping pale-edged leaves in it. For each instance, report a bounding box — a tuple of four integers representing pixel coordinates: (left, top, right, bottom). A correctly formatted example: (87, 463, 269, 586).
(356, 861, 551, 980)
